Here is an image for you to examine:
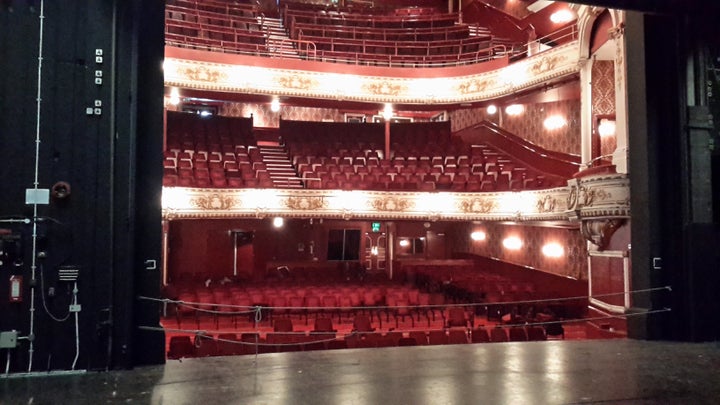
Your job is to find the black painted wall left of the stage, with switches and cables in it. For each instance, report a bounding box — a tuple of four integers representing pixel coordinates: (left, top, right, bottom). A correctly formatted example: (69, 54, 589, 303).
(0, 0, 164, 372)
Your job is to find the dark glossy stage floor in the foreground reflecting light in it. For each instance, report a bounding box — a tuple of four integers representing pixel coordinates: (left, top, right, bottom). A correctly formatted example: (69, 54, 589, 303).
(0, 339, 720, 405)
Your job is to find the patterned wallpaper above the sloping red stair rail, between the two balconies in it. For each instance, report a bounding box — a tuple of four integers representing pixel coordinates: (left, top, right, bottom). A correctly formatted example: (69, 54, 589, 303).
(501, 100, 580, 155)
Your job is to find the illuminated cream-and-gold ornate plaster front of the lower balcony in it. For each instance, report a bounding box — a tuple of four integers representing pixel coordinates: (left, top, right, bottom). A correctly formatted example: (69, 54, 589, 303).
(163, 187, 570, 222)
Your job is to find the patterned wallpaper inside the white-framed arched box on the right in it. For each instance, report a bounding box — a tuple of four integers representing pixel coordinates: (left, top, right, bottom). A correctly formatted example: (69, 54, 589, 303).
(592, 60, 617, 156)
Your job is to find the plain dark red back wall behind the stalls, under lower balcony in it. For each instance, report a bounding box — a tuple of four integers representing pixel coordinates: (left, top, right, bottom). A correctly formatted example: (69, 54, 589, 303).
(168, 218, 450, 283)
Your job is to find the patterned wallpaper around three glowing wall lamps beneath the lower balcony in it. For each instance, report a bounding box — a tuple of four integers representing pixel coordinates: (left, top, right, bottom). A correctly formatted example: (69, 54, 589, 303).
(448, 222, 588, 280)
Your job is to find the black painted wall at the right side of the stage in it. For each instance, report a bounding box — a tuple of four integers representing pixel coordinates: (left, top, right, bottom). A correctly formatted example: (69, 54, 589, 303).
(625, 10, 720, 341)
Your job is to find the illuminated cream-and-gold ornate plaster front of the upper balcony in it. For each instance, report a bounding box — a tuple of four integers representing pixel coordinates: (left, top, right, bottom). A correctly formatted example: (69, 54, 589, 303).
(164, 41, 579, 104)
